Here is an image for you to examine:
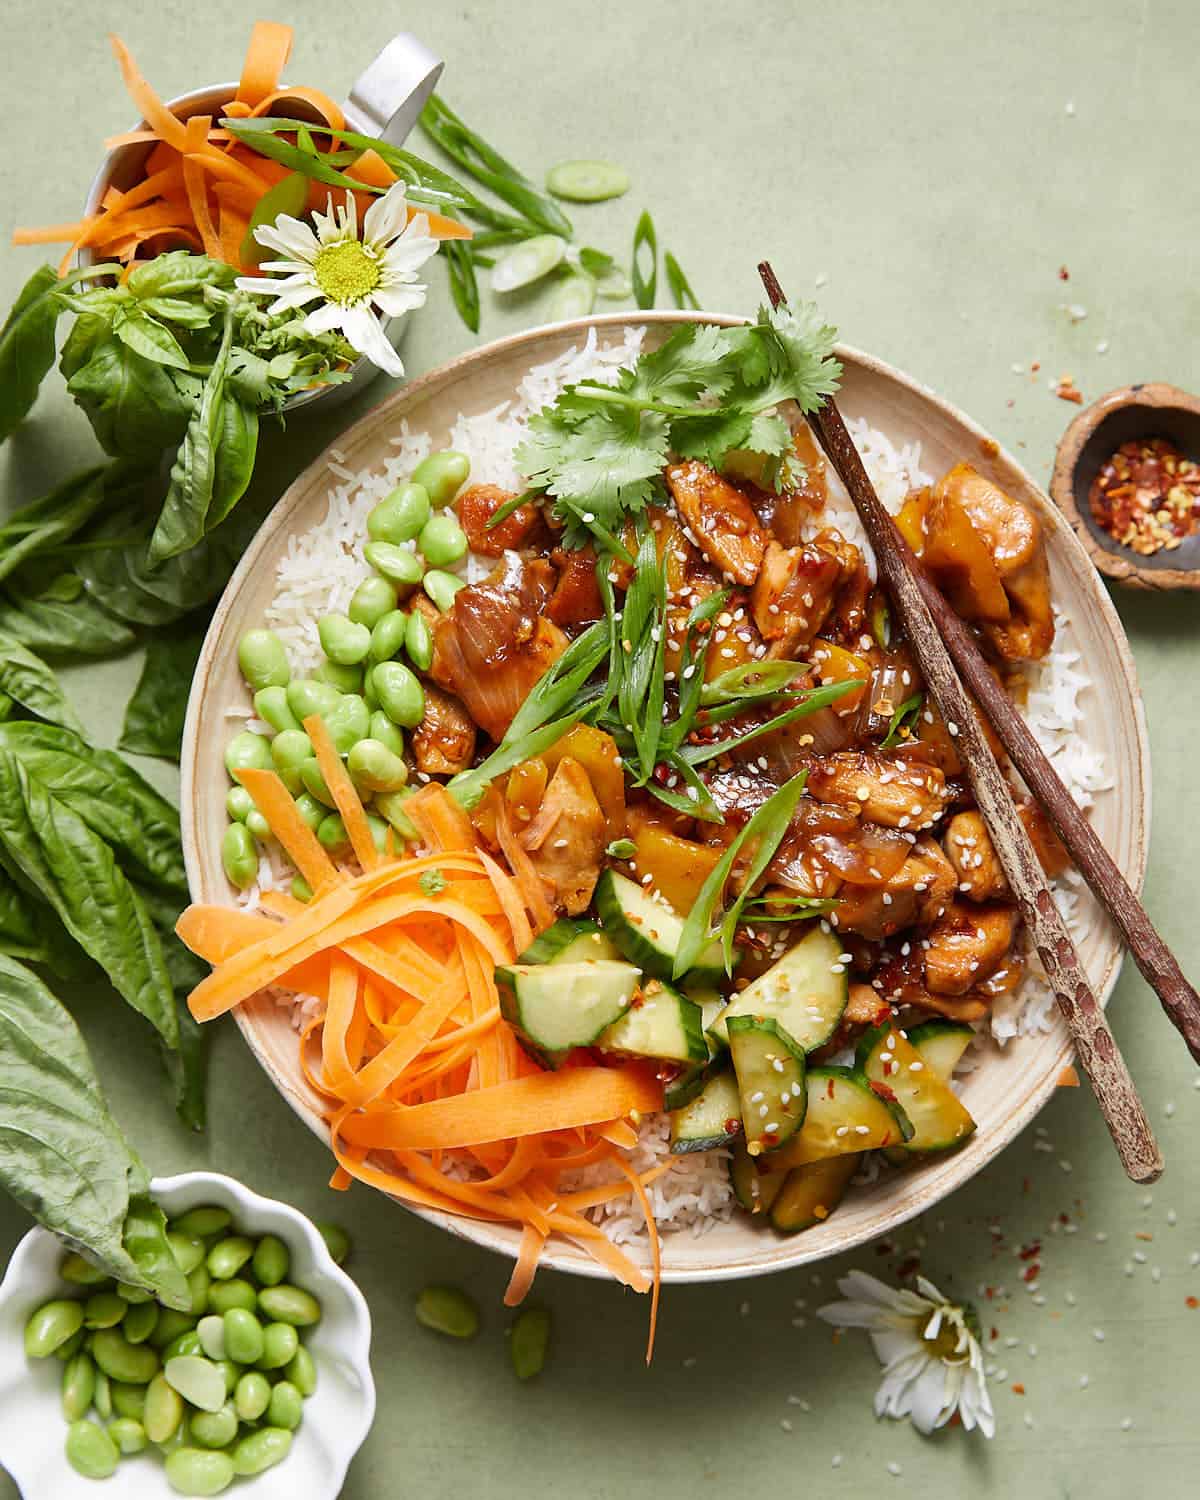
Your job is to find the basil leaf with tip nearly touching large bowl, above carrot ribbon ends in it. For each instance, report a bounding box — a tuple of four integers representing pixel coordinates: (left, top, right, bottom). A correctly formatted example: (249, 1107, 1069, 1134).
(0, 723, 188, 894)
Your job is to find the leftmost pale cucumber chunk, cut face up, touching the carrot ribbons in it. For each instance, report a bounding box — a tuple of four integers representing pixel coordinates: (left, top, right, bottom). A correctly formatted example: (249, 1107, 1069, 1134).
(497, 960, 642, 1067)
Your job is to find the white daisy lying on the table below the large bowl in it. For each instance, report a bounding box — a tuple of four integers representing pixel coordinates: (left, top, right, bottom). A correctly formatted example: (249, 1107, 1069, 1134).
(818, 1271, 996, 1437)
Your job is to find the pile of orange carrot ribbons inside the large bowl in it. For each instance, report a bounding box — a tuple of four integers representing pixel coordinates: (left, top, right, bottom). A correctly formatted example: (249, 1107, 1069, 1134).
(177, 780, 668, 1347)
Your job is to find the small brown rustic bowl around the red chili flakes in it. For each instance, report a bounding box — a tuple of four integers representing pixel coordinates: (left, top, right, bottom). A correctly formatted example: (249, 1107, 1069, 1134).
(1050, 383, 1200, 591)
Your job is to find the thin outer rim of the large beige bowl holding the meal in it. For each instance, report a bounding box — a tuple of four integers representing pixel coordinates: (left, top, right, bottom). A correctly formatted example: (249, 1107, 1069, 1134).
(180, 309, 1152, 1284)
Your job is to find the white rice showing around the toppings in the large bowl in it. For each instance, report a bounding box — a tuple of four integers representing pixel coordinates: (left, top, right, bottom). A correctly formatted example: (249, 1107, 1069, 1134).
(231, 329, 1113, 1247)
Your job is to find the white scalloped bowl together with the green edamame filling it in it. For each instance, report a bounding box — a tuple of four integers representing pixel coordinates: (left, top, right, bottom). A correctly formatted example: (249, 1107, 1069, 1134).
(0, 1172, 375, 1500)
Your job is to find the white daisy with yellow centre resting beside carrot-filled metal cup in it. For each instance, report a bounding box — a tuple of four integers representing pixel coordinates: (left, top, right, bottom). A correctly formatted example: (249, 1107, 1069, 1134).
(237, 183, 438, 375)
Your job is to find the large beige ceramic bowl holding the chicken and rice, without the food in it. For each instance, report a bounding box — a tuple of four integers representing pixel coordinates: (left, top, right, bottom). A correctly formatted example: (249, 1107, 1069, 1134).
(183, 312, 1151, 1281)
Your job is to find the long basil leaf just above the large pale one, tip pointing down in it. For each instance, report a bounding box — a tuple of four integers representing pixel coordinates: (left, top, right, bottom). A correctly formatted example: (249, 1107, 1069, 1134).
(0, 750, 179, 1047)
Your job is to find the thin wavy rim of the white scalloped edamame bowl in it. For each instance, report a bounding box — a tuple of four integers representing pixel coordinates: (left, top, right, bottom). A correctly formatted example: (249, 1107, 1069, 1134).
(0, 1170, 377, 1500)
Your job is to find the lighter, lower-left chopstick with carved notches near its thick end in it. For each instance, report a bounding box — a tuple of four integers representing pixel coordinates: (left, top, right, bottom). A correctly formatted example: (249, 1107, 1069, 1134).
(759, 261, 1163, 1182)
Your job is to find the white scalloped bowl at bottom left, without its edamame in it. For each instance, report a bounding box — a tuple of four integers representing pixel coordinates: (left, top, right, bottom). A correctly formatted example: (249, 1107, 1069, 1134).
(0, 1172, 375, 1500)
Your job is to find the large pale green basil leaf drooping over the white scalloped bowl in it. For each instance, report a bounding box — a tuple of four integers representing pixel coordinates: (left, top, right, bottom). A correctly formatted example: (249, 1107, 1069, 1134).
(0, 957, 189, 1310)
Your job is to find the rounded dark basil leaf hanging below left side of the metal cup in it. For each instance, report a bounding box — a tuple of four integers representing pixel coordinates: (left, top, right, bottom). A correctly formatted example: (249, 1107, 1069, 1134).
(63, 324, 192, 464)
